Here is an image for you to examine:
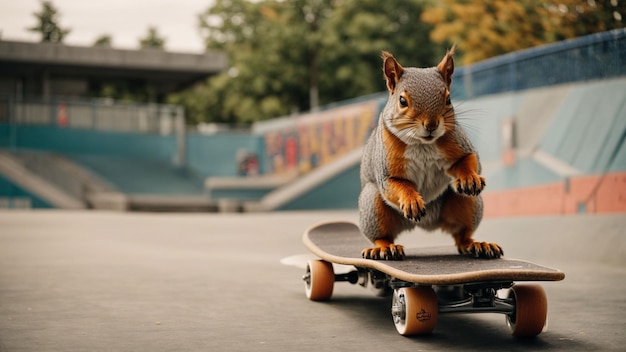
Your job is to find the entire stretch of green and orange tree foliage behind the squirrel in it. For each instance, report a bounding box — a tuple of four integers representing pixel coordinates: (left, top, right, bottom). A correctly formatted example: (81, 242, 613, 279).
(170, 0, 626, 124)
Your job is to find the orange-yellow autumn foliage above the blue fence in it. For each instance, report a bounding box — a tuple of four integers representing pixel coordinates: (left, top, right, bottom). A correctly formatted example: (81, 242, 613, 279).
(421, 0, 626, 63)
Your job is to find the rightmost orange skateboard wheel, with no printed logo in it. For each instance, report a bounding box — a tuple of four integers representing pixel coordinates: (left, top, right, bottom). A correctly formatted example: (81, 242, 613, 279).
(506, 285, 548, 337)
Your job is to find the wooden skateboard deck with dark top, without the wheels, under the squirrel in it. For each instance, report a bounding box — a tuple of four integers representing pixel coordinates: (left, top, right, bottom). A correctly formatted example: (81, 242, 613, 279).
(303, 222, 565, 285)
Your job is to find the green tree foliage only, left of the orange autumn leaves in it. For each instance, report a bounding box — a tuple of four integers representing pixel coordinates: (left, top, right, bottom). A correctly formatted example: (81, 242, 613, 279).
(171, 0, 438, 124)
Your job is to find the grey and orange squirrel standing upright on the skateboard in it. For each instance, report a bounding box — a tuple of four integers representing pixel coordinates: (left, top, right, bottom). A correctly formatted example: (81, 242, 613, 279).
(358, 46, 503, 260)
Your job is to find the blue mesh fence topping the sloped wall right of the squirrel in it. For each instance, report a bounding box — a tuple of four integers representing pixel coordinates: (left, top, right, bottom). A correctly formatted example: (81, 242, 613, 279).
(452, 28, 626, 100)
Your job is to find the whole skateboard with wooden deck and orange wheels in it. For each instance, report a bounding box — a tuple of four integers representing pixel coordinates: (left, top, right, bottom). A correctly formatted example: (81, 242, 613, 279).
(303, 222, 565, 337)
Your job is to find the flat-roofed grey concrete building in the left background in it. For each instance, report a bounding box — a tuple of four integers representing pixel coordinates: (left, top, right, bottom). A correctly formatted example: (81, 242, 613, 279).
(0, 41, 227, 102)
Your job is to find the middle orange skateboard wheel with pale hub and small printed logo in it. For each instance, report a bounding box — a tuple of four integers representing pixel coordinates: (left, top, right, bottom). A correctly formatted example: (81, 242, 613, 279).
(391, 287, 439, 336)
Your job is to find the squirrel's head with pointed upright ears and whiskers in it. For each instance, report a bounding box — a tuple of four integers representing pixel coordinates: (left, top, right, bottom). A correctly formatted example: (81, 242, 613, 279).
(382, 47, 454, 144)
